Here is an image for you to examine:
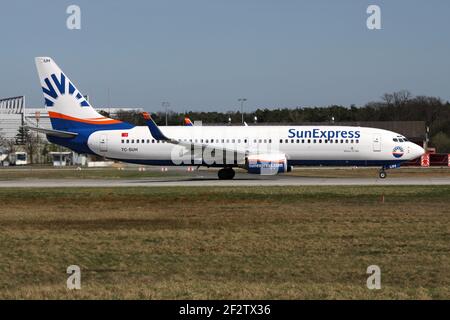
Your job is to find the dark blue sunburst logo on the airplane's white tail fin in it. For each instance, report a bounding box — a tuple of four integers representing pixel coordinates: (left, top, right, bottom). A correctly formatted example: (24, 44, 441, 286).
(42, 72, 90, 107)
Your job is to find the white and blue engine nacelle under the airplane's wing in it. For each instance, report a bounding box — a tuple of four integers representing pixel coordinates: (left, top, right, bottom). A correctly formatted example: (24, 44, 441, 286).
(245, 153, 292, 175)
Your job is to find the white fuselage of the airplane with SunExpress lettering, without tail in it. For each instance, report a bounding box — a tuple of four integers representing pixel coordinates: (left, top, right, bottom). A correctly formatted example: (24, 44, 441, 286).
(88, 126, 424, 166)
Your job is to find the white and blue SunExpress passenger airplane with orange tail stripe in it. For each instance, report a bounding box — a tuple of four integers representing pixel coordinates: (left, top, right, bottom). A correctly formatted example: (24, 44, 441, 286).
(30, 57, 424, 179)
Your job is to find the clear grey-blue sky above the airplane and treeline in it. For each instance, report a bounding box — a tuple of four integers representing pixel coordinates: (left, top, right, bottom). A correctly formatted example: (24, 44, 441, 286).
(0, 0, 450, 112)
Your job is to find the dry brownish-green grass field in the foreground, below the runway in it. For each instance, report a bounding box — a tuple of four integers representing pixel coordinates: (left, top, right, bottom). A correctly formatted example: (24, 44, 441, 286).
(0, 186, 450, 299)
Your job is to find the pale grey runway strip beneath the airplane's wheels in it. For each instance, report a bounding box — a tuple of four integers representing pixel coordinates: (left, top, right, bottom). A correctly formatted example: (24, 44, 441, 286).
(0, 174, 450, 188)
